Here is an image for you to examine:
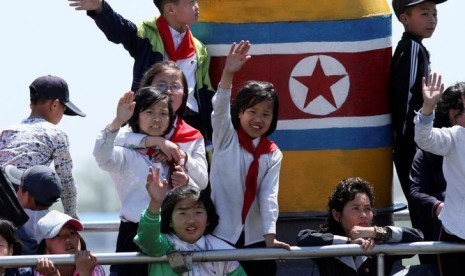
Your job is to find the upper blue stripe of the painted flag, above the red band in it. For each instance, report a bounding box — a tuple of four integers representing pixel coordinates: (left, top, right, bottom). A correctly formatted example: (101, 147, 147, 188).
(192, 15, 392, 45)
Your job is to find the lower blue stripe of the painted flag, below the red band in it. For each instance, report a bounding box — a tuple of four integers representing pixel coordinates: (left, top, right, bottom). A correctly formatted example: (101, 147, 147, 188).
(270, 125, 392, 151)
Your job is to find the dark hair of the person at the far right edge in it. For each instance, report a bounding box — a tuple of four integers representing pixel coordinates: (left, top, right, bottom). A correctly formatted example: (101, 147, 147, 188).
(434, 82, 465, 128)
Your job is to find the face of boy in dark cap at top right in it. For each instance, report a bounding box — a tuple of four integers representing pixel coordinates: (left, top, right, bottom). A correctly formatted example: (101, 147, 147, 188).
(401, 1, 438, 40)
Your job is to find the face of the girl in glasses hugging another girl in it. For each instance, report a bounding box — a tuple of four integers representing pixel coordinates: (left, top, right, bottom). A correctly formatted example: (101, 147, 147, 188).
(151, 69, 184, 113)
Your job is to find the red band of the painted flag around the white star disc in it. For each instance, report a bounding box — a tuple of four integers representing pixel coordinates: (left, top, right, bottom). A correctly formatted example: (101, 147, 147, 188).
(210, 48, 391, 120)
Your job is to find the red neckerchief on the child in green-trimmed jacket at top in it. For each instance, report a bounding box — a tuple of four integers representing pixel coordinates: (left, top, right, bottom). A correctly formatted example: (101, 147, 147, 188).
(156, 16, 195, 62)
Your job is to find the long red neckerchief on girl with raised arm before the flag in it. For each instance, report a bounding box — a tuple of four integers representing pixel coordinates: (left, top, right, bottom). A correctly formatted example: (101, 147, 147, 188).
(237, 128, 278, 224)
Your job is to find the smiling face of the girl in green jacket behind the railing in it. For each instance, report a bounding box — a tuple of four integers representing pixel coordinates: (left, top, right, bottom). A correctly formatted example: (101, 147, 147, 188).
(170, 198, 208, 243)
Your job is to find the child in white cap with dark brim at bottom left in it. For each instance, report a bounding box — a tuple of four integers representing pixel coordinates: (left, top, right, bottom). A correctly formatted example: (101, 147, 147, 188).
(35, 210, 105, 276)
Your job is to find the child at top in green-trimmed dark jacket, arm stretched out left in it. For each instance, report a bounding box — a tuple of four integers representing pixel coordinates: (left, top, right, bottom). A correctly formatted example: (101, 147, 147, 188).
(69, 0, 214, 144)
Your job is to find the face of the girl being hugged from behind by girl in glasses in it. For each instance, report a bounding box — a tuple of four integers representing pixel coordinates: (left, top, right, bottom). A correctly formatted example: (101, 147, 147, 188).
(137, 100, 170, 136)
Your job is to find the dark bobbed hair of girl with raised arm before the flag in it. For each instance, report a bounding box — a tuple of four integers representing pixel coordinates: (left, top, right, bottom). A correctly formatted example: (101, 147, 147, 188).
(231, 81, 279, 136)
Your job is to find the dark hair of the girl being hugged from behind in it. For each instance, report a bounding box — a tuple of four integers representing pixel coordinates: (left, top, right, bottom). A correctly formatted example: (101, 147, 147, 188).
(128, 86, 175, 135)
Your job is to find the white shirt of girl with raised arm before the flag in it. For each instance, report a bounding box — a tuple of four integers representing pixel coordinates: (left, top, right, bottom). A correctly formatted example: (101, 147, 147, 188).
(210, 89, 282, 245)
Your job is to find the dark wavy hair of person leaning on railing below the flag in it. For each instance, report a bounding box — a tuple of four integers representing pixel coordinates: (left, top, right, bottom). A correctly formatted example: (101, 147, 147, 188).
(320, 177, 375, 236)
